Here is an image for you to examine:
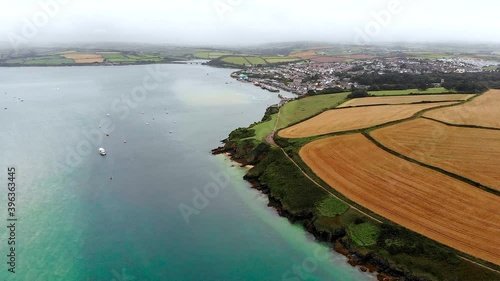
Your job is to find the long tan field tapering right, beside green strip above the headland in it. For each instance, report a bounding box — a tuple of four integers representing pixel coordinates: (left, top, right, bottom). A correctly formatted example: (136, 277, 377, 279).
(278, 102, 455, 138)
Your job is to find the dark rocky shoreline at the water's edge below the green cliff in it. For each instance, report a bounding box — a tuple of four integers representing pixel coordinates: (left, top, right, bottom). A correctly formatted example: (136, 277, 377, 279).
(212, 143, 426, 281)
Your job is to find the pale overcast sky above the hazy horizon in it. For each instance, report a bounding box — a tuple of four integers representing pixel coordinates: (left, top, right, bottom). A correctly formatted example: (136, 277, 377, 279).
(0, 0, 500, 45)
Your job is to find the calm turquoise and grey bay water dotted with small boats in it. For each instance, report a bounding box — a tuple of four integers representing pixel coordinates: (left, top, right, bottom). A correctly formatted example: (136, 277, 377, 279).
(0, 65, 374, 281)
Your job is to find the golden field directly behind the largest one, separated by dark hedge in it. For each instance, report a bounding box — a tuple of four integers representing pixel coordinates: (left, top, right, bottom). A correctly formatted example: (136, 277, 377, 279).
(371, 118, 500, 190)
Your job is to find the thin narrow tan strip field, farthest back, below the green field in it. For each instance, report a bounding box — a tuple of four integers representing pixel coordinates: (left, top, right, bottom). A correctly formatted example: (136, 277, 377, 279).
(338, 94, 474, 108)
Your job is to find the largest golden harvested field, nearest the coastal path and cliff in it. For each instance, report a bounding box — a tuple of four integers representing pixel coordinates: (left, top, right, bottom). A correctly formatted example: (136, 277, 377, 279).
(300, 134, 500, 265)
